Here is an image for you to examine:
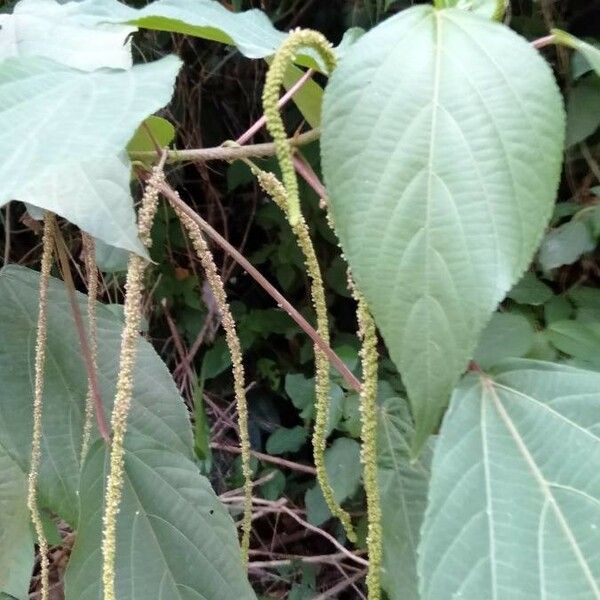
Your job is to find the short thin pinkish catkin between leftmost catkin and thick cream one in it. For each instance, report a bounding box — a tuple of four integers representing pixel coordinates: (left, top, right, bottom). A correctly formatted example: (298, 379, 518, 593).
(79, 233, 98, 464)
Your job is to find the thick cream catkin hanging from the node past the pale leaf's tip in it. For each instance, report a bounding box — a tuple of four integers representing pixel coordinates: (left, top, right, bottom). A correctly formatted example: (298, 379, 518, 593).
(102, 167, 164, 600)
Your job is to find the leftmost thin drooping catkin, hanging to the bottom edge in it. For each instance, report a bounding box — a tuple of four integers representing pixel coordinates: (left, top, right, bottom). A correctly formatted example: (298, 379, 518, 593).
(27, 212, 55, 600)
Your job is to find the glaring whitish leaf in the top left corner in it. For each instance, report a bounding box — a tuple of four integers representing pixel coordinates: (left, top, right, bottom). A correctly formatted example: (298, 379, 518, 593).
(0, 0, 136, 71)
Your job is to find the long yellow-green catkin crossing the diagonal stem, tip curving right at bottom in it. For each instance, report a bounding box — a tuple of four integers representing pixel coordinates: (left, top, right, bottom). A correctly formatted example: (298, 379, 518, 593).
(251, 165, 356, 541)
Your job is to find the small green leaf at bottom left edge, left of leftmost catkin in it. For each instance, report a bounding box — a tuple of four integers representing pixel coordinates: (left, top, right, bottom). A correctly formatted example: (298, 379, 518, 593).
(0, 448, 33, 600)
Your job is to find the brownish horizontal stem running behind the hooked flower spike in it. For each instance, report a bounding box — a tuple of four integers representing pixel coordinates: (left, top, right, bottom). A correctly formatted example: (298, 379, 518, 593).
(129, 129, 321, 164)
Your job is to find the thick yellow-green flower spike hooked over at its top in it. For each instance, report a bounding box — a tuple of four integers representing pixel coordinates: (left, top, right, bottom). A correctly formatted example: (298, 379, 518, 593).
(263, 29, 336, 226)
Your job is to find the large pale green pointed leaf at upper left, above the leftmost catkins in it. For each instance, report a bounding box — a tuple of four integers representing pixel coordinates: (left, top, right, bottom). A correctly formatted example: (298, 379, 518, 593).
(0, 56, 181, 255)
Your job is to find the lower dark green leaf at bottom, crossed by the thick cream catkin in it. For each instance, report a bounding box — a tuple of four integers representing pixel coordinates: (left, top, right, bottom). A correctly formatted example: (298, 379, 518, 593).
(65, 438, 255, 600)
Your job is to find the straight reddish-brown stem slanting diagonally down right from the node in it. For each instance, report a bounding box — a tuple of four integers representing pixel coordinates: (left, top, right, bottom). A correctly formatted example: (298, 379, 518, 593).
(158, 183, 362, 393)
